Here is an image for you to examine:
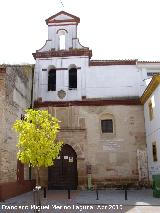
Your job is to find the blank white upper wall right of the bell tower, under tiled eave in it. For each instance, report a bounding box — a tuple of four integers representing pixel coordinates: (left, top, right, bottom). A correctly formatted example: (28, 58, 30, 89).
(86, 65, 141, 98)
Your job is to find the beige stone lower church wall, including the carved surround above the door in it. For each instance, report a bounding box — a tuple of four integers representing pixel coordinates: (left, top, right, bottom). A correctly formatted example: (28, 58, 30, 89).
(37, 105, 146, 187)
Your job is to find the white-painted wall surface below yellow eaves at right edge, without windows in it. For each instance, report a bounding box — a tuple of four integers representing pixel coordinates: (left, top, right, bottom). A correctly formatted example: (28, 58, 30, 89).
(144, 86, 160, 179)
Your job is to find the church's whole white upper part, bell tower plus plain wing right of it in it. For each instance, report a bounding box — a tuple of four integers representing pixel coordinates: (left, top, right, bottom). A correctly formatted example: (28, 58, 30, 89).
(33, 11, 146, 101)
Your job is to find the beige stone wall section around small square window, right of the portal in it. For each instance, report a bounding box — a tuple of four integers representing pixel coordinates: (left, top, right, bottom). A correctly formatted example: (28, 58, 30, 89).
(81, 105, 146, 186)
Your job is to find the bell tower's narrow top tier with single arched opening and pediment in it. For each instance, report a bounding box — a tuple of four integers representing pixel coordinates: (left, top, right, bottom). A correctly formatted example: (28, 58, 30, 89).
(33, 11, 91, 54)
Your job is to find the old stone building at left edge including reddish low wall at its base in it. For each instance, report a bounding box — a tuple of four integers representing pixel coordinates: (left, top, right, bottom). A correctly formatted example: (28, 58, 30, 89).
(0, 65, 33, 200)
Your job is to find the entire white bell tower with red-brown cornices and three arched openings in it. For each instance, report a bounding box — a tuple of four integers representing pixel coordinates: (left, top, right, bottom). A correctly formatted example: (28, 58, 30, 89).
(33, 11, 92, 102)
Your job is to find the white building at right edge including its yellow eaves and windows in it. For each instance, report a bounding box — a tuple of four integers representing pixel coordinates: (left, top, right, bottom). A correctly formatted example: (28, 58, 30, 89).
(141, 74, 160, 180)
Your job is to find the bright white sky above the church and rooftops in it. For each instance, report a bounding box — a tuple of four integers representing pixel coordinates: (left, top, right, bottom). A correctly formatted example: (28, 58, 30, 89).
(0, 0, 160, 64)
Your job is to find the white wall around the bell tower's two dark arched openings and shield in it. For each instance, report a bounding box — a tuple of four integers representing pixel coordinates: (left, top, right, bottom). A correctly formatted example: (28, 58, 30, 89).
(34, 57, 88, 101)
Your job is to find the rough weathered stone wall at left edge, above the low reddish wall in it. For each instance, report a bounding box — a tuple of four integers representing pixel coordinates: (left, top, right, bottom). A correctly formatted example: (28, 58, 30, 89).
(0, 65, 32, 183)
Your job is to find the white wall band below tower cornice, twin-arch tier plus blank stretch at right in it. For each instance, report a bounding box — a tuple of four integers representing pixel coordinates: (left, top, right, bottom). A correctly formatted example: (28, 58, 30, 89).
(35, 57, 148, 101)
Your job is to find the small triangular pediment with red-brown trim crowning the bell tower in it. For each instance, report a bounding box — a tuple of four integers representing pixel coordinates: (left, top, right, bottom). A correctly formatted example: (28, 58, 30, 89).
(46, 11, 80, 24)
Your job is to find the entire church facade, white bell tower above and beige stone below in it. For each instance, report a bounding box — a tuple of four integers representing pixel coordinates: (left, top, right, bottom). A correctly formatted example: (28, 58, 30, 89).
(33, 11, 153, 188)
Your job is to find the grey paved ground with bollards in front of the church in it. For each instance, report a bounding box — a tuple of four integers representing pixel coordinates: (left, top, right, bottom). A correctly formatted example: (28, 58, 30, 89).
(0, 189, 160, 213)
